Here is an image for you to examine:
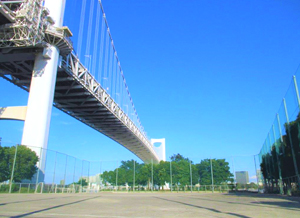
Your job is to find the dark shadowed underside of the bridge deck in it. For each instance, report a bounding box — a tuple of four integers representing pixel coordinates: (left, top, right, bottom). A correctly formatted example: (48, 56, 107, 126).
(0, 48, 155, 161)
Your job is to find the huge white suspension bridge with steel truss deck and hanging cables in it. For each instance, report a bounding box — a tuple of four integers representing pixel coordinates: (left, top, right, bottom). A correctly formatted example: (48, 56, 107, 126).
(0, 0, 165, 168)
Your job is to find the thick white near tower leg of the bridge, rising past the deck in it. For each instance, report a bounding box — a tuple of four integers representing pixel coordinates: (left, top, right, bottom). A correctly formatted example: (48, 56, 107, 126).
(22, 0, 65, 182)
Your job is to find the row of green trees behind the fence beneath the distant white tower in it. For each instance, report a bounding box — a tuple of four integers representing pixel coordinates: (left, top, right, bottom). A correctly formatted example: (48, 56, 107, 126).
(101, 154, 234, 187)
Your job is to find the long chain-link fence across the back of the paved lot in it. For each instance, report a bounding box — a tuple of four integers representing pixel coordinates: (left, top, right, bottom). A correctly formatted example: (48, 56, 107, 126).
(0, 145, 258, 193)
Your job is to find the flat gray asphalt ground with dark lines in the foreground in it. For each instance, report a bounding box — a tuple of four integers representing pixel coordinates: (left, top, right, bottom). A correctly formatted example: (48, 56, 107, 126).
(0, 193, 300, 218)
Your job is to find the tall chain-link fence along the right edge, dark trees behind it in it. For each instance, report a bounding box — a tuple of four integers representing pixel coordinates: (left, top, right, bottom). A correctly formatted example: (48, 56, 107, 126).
(256, 71, 300, 195)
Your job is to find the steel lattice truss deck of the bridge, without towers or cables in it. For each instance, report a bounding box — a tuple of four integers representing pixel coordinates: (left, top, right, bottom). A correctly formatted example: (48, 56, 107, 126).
(0, 0, 159, 162)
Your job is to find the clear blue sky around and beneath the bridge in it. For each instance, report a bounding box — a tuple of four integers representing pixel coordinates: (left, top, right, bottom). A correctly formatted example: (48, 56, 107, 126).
(0, 0, 300, 175)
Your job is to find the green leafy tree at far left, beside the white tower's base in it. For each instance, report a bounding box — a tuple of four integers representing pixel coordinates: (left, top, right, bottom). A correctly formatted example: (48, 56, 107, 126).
(0, 145, 38, 182)
